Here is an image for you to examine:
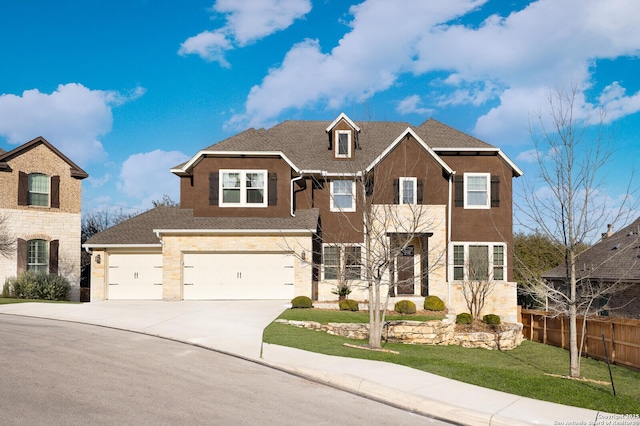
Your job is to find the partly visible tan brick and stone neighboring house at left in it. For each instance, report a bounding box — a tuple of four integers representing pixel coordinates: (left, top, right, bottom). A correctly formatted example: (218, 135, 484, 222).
(0, 137, 88, 300)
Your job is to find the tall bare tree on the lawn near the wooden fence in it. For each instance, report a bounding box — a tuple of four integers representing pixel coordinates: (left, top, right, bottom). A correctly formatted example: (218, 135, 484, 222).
(519, 87, 631, 377)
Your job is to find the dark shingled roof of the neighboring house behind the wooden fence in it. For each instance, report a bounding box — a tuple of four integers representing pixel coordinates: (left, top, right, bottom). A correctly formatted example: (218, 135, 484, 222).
(544, 218, 640, 283)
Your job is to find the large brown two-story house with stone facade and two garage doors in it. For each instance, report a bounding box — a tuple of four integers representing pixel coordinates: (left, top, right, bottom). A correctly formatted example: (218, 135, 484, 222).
(85, 114, 522, 320)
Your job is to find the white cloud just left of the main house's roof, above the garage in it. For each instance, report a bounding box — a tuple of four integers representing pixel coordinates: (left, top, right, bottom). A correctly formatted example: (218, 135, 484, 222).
(117, 149, 189, 208)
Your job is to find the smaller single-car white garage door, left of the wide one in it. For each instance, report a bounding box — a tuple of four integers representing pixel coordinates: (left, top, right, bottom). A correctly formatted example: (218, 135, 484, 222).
(107, 254, 162, 299)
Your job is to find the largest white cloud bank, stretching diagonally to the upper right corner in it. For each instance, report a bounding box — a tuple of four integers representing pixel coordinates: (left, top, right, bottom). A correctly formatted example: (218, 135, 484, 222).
(228, 0, 640, 143)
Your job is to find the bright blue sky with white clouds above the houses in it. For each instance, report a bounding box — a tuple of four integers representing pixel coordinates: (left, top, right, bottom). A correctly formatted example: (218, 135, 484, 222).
(0, 0, 640, 231)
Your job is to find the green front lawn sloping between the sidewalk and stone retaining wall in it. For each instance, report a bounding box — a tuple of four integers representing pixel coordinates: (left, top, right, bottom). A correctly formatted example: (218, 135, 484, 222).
(264, 309, 640, 414)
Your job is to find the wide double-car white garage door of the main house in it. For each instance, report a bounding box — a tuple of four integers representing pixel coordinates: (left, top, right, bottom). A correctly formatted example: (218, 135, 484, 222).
(183, 253, 294, 300)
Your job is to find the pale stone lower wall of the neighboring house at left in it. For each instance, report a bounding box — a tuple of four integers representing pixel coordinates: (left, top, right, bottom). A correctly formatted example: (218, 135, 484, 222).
(0, 208, 81, 301)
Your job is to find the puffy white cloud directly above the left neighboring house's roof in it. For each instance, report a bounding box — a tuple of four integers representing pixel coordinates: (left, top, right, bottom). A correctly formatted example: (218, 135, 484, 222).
(0, 83, 144, 166)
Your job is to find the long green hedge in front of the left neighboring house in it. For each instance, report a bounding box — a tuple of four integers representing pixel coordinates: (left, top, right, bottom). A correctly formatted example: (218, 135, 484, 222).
(2, 271, 71, 300)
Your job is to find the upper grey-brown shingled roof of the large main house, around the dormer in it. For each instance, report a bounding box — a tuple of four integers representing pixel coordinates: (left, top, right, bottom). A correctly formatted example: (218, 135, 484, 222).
(176, 119, 496, 173)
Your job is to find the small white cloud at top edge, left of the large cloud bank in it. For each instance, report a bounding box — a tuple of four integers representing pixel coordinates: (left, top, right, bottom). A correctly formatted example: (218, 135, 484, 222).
(178, 0, 311, 67)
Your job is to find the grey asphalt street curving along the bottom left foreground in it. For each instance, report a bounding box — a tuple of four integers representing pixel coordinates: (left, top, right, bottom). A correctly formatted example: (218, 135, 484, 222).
(0, 315, 447, 426)
